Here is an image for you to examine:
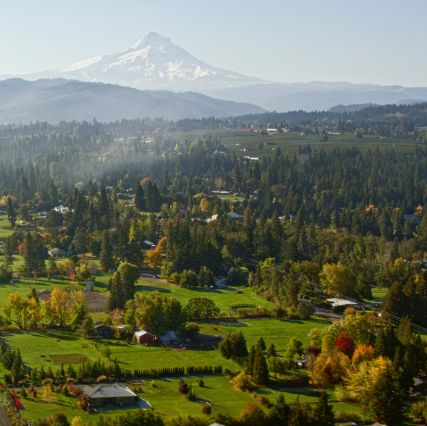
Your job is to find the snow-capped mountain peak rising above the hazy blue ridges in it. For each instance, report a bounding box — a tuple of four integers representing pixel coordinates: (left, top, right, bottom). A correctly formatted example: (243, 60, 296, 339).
(11, 32, 263, 91)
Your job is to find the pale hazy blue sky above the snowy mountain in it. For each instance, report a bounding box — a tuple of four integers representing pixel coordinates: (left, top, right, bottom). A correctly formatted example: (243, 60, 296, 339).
(0, 0, 427, 86)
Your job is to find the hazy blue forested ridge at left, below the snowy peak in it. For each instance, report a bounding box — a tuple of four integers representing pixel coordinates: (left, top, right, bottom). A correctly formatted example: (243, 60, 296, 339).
(0, 79, 264, 124)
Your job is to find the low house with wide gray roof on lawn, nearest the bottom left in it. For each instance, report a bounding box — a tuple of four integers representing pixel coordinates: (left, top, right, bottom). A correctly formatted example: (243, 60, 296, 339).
(83, 383, 138, 407)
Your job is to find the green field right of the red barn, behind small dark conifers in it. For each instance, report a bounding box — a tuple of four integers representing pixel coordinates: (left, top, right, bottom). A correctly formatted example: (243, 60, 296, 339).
(200, 319, 330, 351)
